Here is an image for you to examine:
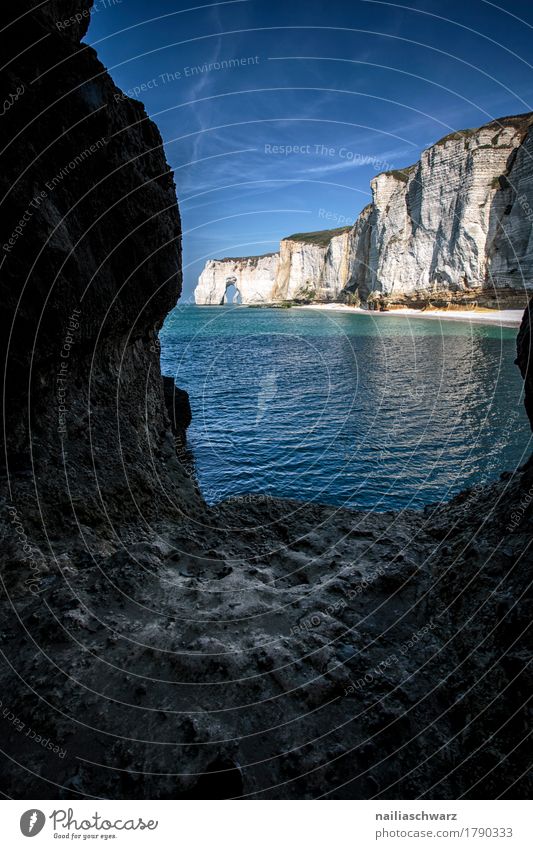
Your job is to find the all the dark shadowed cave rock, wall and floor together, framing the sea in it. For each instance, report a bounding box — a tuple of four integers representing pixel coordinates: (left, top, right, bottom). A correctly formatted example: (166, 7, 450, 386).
(0, 0, 533, 802)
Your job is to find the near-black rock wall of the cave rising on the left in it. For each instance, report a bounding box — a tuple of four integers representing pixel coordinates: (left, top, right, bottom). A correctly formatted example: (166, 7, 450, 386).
(0, 0, 201, 523)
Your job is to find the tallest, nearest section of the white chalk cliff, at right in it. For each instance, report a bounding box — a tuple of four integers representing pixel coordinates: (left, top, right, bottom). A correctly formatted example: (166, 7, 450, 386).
(351, 115, 533, 306)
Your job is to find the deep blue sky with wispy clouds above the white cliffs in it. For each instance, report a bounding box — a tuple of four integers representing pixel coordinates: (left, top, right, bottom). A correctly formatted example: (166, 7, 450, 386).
(86, 0, 533, 298)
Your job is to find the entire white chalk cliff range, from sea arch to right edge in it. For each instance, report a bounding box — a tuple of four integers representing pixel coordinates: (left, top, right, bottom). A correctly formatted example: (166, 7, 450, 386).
(195, 114, 533, 306)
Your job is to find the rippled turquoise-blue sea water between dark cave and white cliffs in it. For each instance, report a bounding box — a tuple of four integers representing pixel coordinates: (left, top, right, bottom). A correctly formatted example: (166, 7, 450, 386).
(161, 306, 533, 510)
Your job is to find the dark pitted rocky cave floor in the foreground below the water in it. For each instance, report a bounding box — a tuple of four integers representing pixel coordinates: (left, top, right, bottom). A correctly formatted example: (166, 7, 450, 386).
(0, 472, 533, 799)
